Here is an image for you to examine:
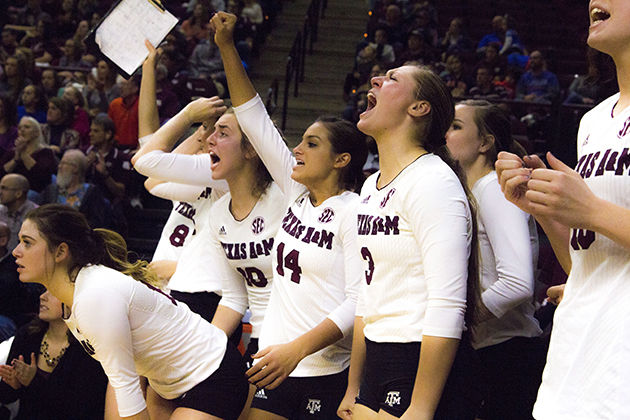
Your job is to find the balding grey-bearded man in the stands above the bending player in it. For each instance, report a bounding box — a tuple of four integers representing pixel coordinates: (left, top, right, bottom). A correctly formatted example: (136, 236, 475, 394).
(40, 149, 112, 229)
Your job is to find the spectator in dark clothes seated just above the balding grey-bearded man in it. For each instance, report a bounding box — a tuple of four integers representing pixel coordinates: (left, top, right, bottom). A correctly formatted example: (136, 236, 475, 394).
(41, 97, 79, 157)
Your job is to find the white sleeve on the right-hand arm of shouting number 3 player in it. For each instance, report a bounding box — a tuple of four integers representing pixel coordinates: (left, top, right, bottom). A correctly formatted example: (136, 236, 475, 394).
(414, 180, 471, 338)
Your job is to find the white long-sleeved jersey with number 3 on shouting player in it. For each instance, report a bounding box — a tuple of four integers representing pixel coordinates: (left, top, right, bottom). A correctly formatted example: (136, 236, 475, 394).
(357, 154, 472, 343)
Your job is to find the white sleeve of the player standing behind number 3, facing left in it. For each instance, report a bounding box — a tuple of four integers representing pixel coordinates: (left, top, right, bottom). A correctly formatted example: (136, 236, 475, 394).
(477, 182, 534, 318)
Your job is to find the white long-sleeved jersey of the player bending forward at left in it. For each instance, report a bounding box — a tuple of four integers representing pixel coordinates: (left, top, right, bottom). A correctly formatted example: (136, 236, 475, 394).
(66, 265, 227, 417)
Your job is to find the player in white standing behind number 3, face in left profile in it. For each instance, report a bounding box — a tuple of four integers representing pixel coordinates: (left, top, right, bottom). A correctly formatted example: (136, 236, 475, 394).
(446, 100, 546, 420)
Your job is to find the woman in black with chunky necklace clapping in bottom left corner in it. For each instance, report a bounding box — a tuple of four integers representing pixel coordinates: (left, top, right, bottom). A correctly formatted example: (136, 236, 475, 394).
(0, 291, 107, 420)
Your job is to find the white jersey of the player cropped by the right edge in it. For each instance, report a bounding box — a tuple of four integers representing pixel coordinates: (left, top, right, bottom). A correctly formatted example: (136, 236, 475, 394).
(534, 94, 630, 420)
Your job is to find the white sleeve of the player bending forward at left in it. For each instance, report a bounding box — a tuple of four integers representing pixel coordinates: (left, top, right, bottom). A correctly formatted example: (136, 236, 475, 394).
(74, 287, 146, 417)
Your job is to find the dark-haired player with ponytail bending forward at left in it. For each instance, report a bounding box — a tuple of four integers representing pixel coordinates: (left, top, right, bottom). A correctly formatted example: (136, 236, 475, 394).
(13, 204, 247, 420)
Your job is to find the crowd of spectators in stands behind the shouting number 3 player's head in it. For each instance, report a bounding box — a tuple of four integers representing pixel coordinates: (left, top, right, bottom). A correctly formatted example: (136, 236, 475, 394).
(343, 0, 614, 148)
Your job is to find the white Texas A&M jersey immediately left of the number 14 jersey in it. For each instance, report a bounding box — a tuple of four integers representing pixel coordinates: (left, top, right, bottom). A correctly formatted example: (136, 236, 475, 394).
(208, 183, 285, 338)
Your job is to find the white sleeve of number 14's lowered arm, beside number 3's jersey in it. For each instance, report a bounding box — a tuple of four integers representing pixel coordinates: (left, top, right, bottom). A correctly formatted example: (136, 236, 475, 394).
(328, 200, 363, 337)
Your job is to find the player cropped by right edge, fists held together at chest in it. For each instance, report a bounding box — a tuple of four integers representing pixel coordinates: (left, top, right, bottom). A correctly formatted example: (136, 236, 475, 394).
(496, 0, 630, 420)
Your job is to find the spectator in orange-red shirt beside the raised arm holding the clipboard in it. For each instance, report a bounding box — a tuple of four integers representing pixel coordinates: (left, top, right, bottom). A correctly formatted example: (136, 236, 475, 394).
(107, 76, 140, 149)
